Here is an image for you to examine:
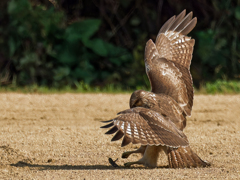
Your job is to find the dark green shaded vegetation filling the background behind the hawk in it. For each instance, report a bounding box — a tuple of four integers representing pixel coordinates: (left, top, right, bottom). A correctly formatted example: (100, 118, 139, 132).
(0, 0, 240, 89)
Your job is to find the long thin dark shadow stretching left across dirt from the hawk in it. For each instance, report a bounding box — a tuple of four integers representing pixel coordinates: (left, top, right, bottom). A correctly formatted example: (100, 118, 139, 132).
(11, 161, 167, 170)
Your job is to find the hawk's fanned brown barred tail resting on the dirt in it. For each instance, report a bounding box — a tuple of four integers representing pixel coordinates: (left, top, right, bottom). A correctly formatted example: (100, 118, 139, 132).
(168, 146, 210, 168)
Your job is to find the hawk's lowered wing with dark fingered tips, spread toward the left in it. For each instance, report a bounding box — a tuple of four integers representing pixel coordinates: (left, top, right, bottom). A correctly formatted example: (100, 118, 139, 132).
(102, 107, 188, 147)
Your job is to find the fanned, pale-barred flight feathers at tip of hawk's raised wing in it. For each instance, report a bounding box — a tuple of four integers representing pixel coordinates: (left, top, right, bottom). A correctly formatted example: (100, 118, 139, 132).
(156, 10, 197, 69)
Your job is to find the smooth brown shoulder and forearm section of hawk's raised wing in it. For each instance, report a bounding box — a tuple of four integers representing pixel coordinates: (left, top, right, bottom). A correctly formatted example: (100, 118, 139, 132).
(145, 39, 188, 109)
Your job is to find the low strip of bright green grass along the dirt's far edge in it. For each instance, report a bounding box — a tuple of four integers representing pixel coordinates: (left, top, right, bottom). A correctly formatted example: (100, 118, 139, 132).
(0, 80, 240, 94)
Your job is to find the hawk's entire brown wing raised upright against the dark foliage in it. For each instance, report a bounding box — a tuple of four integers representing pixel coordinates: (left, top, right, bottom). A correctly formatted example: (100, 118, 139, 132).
(145, 10, 197, 116)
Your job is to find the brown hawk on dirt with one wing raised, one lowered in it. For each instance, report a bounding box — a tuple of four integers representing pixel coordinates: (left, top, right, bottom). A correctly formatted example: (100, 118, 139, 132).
(102, 10, 210, 168)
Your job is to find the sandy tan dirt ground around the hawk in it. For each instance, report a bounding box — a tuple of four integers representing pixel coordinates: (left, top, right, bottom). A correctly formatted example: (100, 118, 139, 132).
(0, 93, 240, 179)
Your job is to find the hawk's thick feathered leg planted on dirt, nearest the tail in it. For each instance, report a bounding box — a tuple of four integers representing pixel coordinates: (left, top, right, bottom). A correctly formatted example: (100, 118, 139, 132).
(124, 146, 162, 168)
